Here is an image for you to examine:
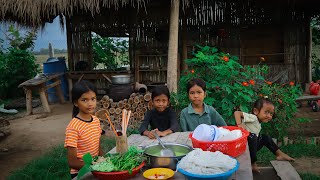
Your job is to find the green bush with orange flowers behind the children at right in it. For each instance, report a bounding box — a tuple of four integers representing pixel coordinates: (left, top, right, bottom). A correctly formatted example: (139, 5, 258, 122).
(171, 46, 301, 137)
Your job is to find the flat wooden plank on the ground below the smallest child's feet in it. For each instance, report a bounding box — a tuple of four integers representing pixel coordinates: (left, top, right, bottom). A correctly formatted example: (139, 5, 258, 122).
(270, 161, 301, 180)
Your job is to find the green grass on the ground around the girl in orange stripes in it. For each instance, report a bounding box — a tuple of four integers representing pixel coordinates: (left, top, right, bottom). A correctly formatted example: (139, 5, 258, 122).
(7, 136, 115, 180)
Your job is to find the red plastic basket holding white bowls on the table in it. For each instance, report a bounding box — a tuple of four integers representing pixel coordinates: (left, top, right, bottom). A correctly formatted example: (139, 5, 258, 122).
(189, 126, 249, 157)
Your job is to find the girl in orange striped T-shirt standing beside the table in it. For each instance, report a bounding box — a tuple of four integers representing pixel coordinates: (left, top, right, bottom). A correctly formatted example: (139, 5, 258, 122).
(64, 81, 104, 178)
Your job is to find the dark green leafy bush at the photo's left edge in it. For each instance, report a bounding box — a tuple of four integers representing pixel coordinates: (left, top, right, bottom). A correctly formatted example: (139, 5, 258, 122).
(0, 26, 39, 98)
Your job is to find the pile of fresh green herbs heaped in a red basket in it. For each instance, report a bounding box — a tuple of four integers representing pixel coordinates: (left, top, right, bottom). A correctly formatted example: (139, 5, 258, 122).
(78, 146, 146, 179)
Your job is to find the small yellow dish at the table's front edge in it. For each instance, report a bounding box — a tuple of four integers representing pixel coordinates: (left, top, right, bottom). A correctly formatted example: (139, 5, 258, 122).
(143, 168, 174, 179)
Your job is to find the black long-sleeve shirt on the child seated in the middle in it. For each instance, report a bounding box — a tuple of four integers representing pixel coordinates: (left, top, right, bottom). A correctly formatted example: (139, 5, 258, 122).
(139, 108, 179, 134)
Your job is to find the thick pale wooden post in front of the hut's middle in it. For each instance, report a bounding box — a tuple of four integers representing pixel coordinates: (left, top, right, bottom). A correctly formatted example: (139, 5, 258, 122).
(167, 0, 180, 92)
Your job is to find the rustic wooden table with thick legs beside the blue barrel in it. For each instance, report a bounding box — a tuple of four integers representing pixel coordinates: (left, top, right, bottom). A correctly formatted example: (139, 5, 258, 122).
(18, 73, 65, 115)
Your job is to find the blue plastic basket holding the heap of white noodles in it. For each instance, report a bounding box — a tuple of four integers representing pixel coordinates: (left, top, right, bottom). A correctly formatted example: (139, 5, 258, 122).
(177, 161, 240, 180)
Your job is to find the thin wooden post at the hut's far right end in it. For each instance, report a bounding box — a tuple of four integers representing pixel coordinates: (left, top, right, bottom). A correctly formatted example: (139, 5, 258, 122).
(306, 17, 312, 83)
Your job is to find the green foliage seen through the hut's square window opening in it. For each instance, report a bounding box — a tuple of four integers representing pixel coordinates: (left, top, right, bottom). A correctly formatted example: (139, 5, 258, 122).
(92, 34, 129, 70)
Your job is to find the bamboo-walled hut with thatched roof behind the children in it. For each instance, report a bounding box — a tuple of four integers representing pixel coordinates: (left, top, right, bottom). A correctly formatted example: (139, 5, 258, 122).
(0, 0, 320, 91)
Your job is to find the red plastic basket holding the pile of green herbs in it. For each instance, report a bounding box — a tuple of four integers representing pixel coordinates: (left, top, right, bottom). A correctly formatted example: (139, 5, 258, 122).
(92, 162, 145, 180)
